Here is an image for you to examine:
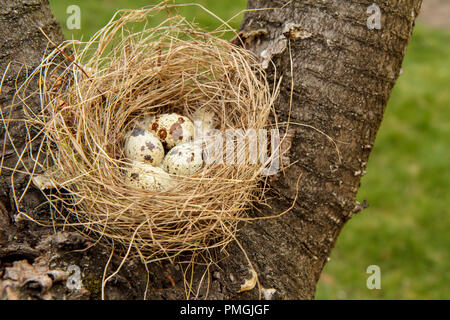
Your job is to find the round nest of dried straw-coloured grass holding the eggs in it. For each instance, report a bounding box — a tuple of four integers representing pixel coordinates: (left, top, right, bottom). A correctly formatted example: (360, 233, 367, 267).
(12, 7, 277, 262)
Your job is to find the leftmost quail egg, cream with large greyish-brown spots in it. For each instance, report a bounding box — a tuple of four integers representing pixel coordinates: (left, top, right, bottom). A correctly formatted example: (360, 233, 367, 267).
(124, 127, 164, 166)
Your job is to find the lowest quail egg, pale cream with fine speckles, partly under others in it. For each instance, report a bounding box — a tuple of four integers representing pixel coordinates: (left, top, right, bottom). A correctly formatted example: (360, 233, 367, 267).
(126, 161, 177, 191)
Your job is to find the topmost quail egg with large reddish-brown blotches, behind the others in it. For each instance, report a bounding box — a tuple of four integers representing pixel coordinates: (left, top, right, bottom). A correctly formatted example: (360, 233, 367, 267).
(150, 113, 194, 149)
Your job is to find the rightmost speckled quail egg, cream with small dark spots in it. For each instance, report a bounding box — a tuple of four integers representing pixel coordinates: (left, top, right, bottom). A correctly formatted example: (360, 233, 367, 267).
(163, 142, 203, 176)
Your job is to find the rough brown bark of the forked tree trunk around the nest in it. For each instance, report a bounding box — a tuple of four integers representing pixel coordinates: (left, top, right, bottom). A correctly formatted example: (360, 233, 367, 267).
(0, 0, 422, 299)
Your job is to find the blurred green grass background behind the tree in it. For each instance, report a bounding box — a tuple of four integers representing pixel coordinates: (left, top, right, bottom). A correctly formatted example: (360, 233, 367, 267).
(50, 0, 450, 299)
